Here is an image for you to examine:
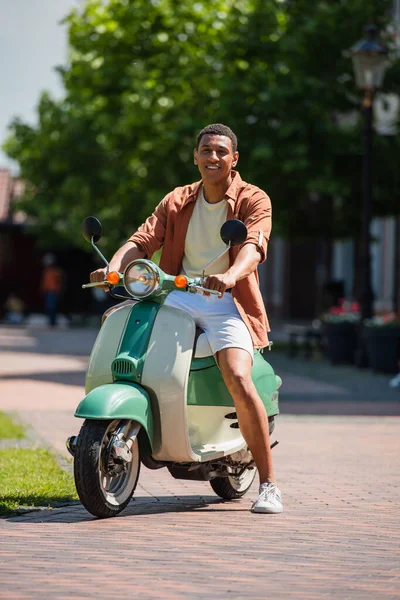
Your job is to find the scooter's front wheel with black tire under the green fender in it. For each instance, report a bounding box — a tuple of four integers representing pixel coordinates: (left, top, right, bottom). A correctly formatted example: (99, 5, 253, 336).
(74, 420, 140, 519)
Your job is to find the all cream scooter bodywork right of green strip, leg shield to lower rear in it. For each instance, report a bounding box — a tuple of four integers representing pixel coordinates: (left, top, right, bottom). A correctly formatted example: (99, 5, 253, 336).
(142, 306, 246, 462)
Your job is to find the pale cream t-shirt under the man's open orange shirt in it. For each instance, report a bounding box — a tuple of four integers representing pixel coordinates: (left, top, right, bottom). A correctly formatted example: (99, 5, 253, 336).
(182, 186, 229, 277)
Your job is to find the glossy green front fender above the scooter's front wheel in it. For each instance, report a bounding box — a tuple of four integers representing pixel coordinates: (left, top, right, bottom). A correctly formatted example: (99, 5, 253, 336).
(75, 383, 154, 448)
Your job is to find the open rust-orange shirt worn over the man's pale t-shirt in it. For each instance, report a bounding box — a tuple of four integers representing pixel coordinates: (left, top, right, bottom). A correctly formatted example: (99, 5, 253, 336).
(129, 171, 272, 348)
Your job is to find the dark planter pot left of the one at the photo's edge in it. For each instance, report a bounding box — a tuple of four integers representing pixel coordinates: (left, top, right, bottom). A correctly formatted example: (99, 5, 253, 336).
(321, 323, 359, 365)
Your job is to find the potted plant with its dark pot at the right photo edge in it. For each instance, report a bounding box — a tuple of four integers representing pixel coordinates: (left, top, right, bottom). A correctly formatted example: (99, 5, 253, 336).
(363, 313, 400, 373)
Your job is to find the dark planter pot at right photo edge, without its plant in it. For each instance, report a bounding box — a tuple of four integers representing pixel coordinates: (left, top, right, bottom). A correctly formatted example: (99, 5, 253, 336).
(363, 325, 400, 373)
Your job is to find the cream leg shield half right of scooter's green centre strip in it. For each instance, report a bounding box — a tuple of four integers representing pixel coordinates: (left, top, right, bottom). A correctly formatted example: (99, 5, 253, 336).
(142, 306, 200, 462)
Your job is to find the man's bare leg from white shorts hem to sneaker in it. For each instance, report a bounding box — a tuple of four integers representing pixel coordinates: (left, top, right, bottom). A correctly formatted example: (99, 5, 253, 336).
(217, 348, 275, 484)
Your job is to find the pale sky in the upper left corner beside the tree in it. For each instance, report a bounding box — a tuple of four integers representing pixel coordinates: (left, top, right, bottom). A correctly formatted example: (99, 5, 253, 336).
(0, 0, 80, 173)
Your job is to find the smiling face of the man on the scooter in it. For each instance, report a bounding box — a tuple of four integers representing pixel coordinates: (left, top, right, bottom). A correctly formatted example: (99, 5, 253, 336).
(194, 134, 239, 183)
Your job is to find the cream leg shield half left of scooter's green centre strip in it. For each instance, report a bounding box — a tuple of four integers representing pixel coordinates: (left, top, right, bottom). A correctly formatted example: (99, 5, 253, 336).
(85, 304, 134, 394)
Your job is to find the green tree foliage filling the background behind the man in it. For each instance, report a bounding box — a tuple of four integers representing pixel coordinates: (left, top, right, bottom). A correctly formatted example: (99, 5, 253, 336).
(6, 0, 400, 250)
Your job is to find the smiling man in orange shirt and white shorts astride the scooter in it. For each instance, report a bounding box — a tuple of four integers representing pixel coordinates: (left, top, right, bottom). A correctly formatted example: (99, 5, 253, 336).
(90, 124, 283, 513)
